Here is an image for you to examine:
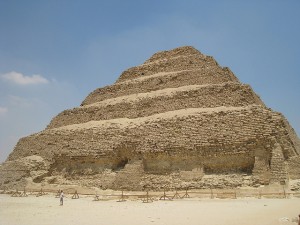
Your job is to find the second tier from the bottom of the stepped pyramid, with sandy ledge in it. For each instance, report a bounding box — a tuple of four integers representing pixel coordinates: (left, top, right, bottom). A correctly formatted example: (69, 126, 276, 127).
(47, 83, 264, 129)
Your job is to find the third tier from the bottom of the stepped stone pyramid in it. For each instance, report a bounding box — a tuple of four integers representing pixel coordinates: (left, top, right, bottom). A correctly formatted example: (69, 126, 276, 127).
(81, 67, 238, 105)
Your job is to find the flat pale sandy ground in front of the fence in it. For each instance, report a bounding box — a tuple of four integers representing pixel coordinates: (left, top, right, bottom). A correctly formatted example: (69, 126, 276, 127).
(0, 194, 300, 225)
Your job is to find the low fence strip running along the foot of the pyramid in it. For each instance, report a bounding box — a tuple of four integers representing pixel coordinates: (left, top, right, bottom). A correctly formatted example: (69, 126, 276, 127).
(0, 188, 300, 203)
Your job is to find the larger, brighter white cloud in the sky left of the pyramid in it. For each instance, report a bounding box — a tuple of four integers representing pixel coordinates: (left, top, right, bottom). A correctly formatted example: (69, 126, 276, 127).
(1, 71, 49, 85)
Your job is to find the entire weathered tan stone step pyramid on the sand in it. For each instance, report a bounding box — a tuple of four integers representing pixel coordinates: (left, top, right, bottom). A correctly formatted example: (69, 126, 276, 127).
(0, 47, 300, 190)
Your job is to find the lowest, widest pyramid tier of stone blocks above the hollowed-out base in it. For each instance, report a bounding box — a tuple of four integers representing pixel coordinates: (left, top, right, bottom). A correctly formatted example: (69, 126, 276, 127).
(9, 105, 296, 165)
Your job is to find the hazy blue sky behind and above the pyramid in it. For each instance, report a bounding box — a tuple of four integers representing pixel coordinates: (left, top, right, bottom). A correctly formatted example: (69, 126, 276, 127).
(0, 0, 300, 162)
